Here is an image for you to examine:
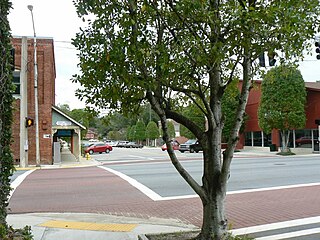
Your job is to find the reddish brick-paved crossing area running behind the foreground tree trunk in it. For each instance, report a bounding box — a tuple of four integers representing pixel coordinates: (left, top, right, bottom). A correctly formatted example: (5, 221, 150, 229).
(9, 168, 320, 229)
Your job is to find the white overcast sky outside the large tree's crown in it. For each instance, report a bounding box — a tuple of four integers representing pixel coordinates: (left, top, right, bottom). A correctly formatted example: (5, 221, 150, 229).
(9, 0, 320, 109)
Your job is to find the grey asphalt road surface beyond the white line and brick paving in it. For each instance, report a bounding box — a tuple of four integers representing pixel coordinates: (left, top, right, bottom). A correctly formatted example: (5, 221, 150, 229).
(93, 148, 320, 197)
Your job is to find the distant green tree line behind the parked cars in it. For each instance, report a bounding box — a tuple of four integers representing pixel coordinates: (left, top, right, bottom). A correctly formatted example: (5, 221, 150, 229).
(58, 81, 239, 145)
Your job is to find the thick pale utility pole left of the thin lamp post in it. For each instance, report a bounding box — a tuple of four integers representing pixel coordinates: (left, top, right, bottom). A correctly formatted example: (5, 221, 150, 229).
(20, 37, 28, 167)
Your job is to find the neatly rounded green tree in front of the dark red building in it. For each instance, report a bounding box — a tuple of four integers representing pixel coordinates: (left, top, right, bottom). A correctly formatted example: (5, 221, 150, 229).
(258, 64, 307, 152)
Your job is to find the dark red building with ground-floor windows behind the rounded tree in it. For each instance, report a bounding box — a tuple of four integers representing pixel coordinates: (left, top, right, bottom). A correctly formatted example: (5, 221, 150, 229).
(240, 81, 320, 152)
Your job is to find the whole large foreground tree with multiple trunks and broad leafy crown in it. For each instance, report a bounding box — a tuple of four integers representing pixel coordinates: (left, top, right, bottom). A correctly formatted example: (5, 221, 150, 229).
(73, 0, 319, 240)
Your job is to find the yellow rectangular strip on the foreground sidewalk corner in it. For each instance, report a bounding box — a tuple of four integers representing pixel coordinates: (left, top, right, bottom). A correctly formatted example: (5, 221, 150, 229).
(38, 220, 137, 232)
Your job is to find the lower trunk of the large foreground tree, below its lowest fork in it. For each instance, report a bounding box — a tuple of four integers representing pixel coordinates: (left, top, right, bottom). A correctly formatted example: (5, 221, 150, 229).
(196, 191, 228, 240)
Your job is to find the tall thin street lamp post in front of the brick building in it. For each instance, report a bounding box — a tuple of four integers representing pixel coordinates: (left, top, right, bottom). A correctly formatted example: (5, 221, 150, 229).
(28, 5, 40, 167)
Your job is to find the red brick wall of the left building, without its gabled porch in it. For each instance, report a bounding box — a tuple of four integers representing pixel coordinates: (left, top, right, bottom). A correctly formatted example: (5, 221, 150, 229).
(12, 38, 56, 164)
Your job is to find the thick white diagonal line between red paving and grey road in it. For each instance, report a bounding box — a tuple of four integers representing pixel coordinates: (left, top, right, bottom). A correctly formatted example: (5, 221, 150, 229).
(98, 166, 162, 201)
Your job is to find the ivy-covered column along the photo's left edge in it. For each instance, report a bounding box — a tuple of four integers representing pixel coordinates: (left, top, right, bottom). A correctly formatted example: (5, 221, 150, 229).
(0, 0, 14, 232)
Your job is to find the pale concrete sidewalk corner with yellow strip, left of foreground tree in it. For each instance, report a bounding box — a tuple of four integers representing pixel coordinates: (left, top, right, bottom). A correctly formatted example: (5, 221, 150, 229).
(7, 213, 198, 240)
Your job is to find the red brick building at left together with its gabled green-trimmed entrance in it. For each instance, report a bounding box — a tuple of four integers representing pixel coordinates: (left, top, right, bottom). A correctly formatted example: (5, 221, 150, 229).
(11, 37, 84, 165)
